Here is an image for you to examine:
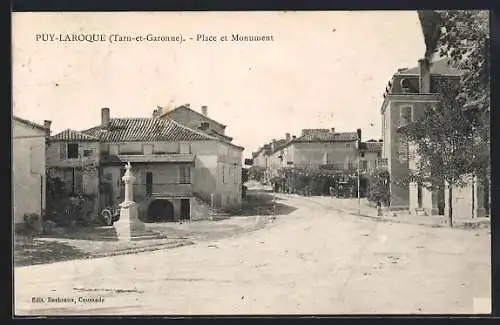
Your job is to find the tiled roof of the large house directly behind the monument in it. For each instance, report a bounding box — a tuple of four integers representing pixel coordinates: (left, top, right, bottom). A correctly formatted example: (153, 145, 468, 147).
(82, 118, 216, 142)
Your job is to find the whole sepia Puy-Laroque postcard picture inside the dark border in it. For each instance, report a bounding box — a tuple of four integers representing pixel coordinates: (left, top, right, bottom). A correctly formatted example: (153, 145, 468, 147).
(12, 10, 491, 316)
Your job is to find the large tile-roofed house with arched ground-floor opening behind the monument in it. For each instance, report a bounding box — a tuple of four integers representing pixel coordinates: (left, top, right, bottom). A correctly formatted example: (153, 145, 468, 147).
(45, 108, 244, 221)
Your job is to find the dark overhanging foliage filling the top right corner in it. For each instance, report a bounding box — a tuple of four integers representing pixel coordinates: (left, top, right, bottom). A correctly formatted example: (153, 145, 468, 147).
(418, 10, 491, 213)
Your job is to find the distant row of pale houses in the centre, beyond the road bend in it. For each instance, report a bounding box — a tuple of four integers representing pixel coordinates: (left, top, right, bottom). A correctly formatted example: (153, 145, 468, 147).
(252, 128, 384, 182)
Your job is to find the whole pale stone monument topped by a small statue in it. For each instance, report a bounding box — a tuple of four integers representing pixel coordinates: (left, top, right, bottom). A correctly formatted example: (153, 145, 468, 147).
(114, 162, 146, 241)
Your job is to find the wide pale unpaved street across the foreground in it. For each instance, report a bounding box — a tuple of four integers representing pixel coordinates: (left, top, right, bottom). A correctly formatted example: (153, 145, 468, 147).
(14, 190, 491, 316)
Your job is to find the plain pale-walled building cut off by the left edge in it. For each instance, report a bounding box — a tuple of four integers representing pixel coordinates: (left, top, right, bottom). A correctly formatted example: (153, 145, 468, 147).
(12, 116, 51, 226)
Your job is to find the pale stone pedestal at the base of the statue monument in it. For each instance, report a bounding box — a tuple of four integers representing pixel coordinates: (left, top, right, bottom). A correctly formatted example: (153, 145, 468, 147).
(113, 202, 147, 241)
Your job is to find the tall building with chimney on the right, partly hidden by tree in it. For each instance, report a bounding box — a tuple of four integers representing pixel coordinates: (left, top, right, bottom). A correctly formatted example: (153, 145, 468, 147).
(381, 58, 490, 217)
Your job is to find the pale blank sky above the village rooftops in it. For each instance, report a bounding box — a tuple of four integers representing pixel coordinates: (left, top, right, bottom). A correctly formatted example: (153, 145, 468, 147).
(12, 11, 425, 156)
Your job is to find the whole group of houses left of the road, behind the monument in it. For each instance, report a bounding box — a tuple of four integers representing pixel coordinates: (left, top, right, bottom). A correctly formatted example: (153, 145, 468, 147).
(12, 104, 244, 228)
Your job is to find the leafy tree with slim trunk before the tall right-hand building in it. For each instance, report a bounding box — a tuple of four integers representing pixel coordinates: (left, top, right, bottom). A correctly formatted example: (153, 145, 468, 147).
(400, 80, 474, 227)
